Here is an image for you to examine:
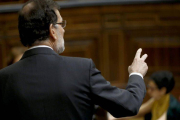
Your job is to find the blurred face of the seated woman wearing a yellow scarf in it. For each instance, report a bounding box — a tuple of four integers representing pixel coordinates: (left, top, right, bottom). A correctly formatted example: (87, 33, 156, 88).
(147, 80, 165, 100)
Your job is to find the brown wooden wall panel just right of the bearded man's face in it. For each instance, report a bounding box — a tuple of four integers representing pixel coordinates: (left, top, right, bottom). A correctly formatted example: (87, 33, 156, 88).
(62, 31, 102, 70)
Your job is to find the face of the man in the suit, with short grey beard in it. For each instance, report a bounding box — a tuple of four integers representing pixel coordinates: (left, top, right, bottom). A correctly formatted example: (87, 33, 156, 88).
(54, 10, 65, 54)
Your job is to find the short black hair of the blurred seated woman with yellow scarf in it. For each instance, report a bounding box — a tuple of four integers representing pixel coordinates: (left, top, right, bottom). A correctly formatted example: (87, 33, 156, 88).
(150, 71, 175, 94)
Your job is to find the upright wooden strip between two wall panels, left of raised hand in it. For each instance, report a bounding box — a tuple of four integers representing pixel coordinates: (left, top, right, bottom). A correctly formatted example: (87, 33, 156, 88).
(103, 31, 127, 86)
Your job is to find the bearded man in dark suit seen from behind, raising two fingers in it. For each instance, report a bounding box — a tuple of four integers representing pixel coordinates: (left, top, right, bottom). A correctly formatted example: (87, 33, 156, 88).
(0, 0, 148, 120)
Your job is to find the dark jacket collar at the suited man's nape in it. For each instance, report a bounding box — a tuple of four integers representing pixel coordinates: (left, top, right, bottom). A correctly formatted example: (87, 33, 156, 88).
(21, 47, 58, 60)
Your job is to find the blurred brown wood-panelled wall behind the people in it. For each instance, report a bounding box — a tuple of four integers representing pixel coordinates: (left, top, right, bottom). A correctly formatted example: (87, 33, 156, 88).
(0, 0, 180, 119)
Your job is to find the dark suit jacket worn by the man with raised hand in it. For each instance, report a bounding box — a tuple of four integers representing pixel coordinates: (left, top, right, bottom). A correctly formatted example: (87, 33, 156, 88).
(0, 48, 146, 120)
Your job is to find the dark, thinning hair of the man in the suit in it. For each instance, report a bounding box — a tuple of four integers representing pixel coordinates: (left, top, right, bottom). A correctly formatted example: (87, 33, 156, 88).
(18, 0, 60, 46)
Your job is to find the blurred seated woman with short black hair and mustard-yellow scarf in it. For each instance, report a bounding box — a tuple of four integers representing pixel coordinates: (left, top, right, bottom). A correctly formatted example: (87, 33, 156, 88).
(110, 71, 180, 120)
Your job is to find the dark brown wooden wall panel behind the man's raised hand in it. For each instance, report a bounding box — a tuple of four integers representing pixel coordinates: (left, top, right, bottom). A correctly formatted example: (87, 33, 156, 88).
(126, 29, 180, 101)
